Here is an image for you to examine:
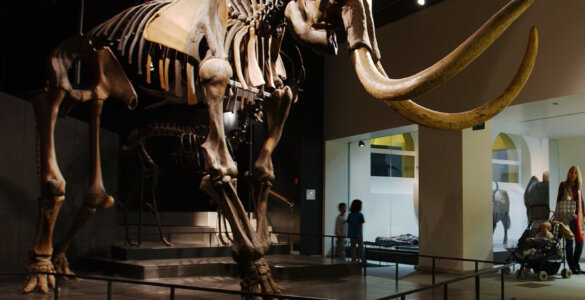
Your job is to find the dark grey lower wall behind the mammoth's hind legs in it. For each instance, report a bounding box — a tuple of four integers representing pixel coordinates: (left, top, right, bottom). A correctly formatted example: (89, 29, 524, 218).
(0, 93, 118, 272)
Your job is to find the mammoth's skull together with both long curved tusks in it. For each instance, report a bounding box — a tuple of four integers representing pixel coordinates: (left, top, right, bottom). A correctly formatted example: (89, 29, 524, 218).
(285, 0, 538, 130)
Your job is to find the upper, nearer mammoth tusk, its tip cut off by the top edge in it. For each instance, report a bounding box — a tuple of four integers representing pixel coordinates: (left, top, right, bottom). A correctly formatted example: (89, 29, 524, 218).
(351, 0, 534, 101)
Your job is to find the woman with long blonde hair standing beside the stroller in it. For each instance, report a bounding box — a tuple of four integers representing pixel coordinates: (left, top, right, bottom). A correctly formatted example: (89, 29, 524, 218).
(555, 166, 585, 274)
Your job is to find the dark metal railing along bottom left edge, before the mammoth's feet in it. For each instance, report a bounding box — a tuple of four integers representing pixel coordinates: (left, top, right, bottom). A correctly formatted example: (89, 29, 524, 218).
(0, 272, 329, 300)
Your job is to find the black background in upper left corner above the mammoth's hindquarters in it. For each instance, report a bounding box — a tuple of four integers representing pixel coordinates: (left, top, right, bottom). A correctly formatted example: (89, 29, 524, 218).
(0, 0, 142, 94)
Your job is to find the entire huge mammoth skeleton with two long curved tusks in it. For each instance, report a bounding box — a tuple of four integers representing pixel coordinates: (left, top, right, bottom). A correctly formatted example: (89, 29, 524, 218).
(23, 0, 538, 293)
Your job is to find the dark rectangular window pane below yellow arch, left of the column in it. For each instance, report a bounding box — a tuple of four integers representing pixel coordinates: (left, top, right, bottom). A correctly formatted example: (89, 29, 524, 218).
(370, 153, 414, 178)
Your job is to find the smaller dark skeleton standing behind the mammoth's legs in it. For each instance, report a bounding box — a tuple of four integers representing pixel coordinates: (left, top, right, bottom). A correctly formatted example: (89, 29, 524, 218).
(117, 103, 250, 246)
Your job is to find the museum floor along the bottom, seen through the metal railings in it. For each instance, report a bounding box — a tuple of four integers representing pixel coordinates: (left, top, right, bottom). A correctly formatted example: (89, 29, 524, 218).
(0, 265, 585, 300)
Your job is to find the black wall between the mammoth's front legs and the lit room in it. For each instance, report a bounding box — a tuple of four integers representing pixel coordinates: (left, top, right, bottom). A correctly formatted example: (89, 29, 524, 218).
(253, 36, 323, 255)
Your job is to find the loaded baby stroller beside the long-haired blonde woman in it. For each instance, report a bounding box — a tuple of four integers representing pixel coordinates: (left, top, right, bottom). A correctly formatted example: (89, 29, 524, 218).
(508, 204, 572, 281)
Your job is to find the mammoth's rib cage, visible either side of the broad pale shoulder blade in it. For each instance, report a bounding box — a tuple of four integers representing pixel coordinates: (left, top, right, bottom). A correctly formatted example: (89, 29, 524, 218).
(86, 0, 288, 108)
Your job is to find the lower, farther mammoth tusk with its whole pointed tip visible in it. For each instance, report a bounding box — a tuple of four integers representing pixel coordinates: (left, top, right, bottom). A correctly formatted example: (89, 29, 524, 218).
(384, 27, 538, 130)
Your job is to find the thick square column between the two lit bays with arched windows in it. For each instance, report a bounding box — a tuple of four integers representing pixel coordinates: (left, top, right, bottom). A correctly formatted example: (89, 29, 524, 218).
(417, 122, 493, 273)
